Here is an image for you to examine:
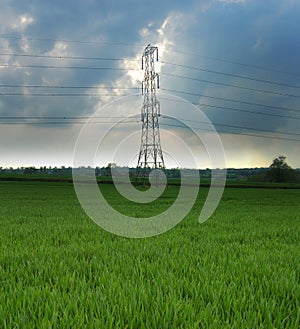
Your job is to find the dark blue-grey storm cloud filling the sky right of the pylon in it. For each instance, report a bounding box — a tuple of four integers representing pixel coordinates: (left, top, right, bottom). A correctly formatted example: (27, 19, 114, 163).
(157, 1, 300, 136)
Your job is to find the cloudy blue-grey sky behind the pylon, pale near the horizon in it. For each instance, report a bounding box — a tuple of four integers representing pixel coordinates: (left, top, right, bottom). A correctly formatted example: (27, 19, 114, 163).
(0, 0, 300, 168)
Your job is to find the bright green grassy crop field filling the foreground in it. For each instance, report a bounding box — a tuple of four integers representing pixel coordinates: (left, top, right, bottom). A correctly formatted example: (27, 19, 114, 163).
(0, 181, 300, 329)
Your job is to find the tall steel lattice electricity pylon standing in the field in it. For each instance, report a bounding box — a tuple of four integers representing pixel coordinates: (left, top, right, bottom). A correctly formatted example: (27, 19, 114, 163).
(136, 44, 165, 178)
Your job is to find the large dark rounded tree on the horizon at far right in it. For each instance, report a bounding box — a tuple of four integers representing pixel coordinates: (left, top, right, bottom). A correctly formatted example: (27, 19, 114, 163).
(266, 155, 299, 183)
